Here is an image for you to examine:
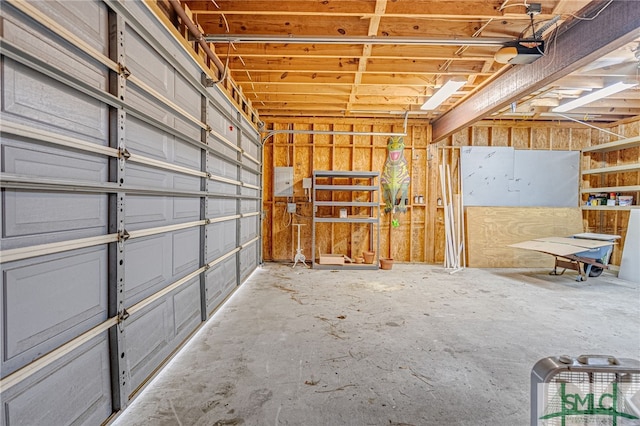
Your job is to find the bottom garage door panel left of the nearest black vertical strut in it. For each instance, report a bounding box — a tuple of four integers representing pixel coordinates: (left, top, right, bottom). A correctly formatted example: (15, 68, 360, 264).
(0, 333, 112, 426)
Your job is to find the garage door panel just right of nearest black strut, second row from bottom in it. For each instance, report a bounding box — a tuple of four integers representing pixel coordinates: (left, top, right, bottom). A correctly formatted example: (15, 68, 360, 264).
(124, 235, 171, 306)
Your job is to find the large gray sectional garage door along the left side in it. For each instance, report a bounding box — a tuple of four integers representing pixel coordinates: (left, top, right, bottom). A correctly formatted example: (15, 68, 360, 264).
(0, 0, 262, 426)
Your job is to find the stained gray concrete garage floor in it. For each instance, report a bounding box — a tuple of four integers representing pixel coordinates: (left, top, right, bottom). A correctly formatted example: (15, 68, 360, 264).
(114, 264, 640, 426)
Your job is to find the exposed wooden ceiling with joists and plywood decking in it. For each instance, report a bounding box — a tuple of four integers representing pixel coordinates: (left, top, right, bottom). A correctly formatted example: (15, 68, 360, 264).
(179, 0, 640, 120)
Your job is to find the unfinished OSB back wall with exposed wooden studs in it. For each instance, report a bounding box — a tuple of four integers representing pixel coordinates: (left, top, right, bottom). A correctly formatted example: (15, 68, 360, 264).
(263, 118, 640, 265)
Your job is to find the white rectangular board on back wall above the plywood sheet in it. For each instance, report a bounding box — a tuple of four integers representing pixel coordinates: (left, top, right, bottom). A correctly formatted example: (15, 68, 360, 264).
(460, 146, 580, 207)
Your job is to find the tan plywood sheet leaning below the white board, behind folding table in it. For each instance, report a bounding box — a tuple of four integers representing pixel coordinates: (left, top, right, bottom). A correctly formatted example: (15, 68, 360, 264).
(466, 207, 582, 268)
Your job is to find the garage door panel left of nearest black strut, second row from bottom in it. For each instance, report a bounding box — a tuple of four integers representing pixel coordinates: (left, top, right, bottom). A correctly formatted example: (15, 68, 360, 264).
(2, 246, 107, 375)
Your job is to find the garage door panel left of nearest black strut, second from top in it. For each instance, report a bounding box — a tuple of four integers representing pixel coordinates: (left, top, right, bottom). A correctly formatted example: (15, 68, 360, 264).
(2, 57, 108, 144)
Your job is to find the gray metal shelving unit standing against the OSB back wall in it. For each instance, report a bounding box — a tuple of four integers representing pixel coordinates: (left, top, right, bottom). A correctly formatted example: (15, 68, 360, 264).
(311, 170, 380, 269)
